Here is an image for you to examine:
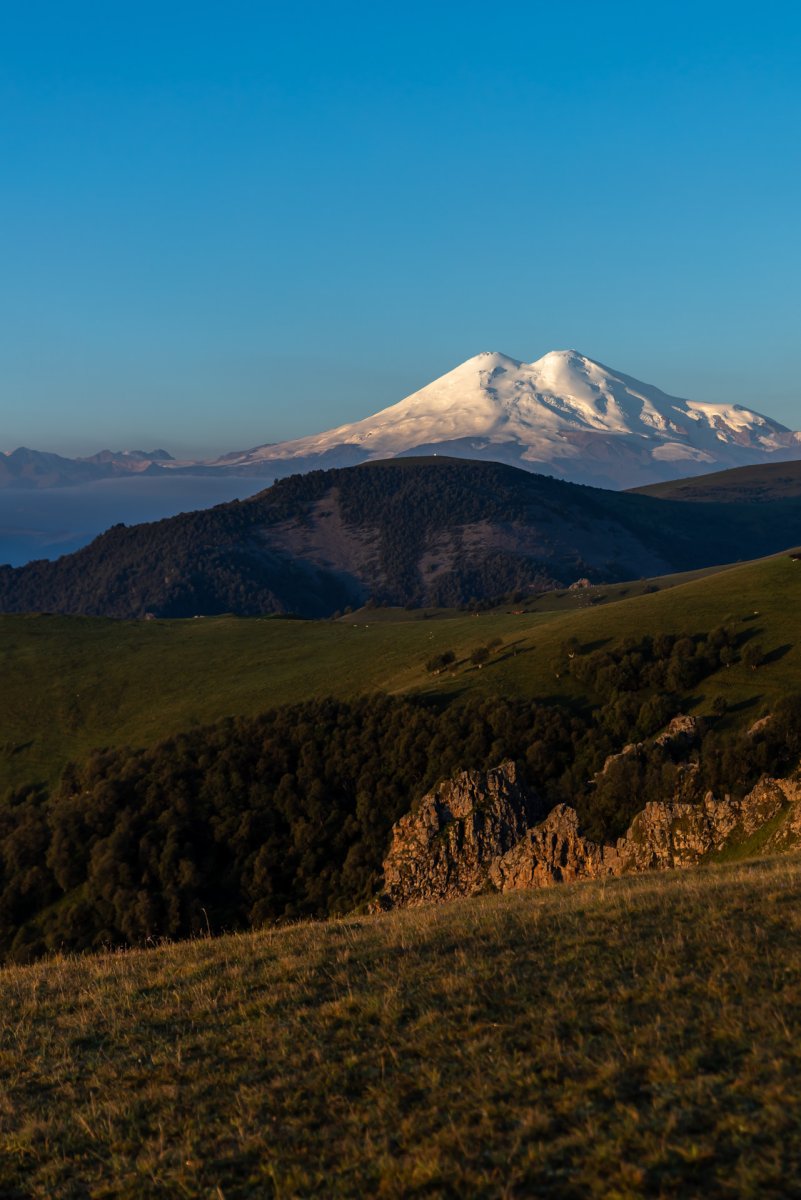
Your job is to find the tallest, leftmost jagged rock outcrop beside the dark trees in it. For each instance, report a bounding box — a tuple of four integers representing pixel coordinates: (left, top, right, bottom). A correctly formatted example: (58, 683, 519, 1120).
(381, 762, 542, 907)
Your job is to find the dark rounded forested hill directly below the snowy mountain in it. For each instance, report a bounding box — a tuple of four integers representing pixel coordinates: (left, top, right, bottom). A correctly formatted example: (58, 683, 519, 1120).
(0, 458, 801, 618)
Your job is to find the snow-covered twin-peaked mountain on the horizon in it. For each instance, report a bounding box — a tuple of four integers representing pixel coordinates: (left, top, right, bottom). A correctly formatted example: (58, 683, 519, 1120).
(210, 350, 801, 487)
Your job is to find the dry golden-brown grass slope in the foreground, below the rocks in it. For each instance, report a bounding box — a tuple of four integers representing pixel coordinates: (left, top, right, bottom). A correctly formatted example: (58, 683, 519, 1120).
(0, 858, 801, 1200)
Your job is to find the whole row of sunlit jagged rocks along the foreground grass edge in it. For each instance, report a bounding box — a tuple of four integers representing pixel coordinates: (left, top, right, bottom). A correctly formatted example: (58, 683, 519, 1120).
(375, 763, 801, 908)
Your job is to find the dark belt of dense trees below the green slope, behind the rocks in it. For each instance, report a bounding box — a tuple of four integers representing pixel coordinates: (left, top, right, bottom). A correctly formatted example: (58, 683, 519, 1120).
(0, 628, 801, 960)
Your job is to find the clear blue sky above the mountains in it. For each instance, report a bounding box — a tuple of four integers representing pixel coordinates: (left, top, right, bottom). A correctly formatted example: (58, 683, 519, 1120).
(0, 0, 801, 454)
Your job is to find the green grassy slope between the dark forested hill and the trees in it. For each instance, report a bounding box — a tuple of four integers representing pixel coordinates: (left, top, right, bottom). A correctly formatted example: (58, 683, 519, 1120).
(0, 554, 801, 791)
